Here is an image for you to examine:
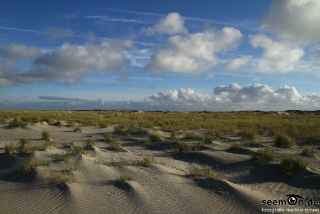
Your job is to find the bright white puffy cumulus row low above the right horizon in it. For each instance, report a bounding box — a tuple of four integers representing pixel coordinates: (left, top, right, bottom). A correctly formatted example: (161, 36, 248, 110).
(147, 83, 320, 111)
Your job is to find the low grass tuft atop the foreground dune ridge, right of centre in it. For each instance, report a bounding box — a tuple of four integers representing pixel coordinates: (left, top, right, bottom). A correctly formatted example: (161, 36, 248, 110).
(188, 163, 223, 180)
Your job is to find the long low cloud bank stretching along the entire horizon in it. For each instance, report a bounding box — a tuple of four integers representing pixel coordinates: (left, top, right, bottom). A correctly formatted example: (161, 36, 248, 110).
(0, 83, 320, 111)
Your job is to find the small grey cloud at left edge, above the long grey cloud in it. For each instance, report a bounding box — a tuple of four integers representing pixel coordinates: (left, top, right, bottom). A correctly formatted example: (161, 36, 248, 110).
(0, 43, 42, 59)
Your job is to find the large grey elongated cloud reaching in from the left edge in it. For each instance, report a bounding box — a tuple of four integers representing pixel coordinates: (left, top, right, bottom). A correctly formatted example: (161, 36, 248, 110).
(0, 40, 133, 86)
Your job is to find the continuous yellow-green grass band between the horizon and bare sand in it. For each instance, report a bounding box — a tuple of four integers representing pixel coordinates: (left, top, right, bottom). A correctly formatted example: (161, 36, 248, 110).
(0, 111, 320, 147)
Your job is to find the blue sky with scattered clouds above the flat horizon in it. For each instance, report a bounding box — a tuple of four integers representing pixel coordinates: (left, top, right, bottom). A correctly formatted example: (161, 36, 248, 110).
(0, 0, 320, 111)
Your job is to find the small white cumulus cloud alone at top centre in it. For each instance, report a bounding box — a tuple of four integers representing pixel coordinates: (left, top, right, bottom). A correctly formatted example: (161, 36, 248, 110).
(142, 13, 188, 35)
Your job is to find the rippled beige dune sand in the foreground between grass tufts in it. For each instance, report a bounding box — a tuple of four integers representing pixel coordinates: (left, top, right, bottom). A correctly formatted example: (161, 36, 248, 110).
(0, 122, 320, 214)
